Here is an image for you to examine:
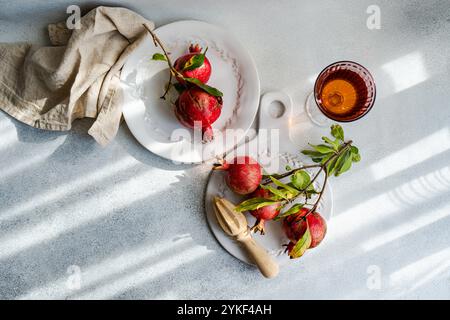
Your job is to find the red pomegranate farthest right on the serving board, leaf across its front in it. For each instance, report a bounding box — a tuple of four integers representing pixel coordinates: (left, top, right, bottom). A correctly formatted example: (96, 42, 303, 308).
(283, 208, 327, 253)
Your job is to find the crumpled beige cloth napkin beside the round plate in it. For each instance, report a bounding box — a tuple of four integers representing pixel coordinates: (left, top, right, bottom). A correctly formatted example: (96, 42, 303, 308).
(0, 7, 154, 146)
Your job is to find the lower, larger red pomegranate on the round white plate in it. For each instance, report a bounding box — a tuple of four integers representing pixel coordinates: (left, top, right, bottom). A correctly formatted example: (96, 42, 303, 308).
(175, 87, 222, 141)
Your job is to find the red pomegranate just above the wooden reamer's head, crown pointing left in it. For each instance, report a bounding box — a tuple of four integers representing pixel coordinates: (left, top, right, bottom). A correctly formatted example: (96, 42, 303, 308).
(214, 156, 262, 195)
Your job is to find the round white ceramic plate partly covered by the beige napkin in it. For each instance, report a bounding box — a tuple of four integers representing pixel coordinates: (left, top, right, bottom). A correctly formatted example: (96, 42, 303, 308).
(121, 21, 260, 163)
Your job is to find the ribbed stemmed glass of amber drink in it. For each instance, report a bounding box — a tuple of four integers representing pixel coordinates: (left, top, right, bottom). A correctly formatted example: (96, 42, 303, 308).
(305, 61, 376, 126)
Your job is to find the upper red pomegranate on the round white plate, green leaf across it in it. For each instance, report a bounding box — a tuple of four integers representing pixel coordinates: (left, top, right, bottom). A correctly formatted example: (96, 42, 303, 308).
(174, 44, 211, 83)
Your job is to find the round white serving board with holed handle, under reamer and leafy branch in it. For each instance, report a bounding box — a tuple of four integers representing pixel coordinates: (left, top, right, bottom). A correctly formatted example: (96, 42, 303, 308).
(205, 92, 333, 265)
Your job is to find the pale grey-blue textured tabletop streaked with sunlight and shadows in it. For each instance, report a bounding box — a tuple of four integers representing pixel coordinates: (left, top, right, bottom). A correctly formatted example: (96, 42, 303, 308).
(0, 0, 450, 299)
